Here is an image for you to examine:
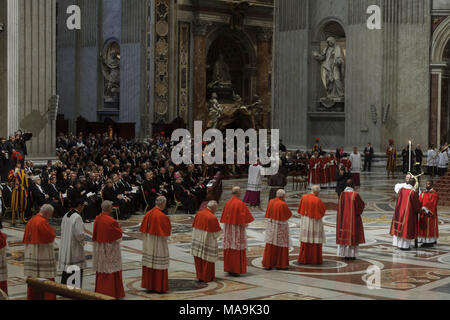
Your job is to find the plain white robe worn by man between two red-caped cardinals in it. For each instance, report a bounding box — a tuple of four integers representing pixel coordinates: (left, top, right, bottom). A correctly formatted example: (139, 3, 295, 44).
(58, 211, 86, 271)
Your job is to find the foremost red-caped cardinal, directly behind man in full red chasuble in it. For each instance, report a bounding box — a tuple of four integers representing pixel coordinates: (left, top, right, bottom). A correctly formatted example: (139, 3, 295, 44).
(298, 185, 326, 264)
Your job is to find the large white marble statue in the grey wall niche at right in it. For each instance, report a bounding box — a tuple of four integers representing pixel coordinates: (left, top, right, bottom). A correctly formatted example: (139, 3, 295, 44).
(313, 37, 345, 108)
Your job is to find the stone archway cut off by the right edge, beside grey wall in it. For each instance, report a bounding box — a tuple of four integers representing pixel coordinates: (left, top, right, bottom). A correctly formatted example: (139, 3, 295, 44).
(430, 17, 450, 146)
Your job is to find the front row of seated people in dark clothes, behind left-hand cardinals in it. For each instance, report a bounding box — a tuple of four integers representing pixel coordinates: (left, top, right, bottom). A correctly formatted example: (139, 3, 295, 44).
(0, 170, 222, 222)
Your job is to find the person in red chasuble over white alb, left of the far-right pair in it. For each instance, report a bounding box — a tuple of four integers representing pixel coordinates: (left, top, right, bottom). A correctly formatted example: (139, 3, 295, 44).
(390, 178, 422, 250)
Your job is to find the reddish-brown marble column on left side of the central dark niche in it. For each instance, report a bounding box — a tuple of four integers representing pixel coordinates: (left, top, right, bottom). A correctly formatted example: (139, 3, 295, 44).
(193, 21, 208, 126)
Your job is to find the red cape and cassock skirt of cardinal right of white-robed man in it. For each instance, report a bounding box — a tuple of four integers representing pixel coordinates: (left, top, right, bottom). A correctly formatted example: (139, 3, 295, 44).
(92, 212, 125, 299)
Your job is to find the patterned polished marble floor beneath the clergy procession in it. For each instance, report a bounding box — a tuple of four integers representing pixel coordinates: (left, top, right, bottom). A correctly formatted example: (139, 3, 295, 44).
(3, 172, 450, 300)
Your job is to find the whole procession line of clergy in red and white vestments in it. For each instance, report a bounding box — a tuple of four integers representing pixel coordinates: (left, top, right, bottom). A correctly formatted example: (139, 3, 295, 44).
(0, 174, 438, 300)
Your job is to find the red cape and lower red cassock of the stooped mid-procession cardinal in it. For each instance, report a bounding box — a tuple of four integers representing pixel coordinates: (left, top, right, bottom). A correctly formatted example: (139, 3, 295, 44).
(192, 208, 222, 282)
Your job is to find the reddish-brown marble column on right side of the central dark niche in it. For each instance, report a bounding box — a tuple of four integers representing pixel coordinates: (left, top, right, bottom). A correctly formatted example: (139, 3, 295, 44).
(251, 29, 272, 128)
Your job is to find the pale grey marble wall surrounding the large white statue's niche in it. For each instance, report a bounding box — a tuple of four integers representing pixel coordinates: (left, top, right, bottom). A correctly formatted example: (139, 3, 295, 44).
(274, 0, 431, 152)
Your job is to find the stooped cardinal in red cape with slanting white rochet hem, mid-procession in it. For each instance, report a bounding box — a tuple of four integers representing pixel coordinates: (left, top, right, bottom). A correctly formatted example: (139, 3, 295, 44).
(191, 201, 222, 282)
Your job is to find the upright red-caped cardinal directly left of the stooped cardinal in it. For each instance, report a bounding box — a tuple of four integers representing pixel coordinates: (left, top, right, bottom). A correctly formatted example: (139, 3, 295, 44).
(139, 196, 172, 293)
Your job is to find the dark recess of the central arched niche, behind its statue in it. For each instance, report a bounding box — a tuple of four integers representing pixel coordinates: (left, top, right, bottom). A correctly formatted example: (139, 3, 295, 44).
(206, 27, 257, 102)
